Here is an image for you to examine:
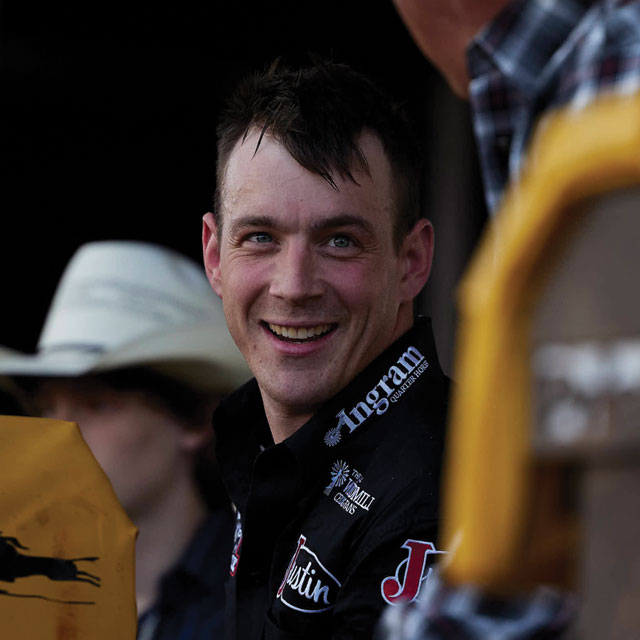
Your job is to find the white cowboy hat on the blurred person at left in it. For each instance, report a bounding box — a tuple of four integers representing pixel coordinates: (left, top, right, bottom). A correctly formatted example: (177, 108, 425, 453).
(0, 241, 251, 393)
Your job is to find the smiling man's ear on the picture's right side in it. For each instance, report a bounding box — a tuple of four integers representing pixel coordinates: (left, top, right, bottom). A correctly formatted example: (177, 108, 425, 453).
(399, 218, 433, 301)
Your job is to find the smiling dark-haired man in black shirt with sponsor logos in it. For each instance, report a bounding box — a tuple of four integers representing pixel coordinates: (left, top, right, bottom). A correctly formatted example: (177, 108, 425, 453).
(203, 63, 448, 639)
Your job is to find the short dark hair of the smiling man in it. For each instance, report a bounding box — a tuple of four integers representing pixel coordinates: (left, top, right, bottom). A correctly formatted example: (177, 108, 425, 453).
(214, 60, 421, 248)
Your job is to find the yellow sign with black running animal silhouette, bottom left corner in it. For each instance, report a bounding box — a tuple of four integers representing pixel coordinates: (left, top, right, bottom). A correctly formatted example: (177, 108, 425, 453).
(0, 416, 137, 640)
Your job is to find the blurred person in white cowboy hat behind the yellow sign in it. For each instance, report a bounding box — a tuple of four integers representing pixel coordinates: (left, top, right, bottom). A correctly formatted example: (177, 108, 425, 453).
(0, 241, 249, 640)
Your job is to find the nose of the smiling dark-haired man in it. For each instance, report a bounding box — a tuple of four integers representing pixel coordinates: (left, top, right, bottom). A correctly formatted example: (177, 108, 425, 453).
(269, 242, 324, 302)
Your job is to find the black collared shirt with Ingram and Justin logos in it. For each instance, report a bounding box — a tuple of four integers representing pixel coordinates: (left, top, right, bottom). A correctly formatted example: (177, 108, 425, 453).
(214, 319, 449, 640)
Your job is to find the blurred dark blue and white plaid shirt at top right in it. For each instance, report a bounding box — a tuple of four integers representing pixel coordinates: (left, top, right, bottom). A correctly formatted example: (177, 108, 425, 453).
(467, 0, 640, 212)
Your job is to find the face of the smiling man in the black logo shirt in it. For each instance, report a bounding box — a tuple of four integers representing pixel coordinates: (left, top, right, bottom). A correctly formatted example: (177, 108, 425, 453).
(204, 131, 431, 430)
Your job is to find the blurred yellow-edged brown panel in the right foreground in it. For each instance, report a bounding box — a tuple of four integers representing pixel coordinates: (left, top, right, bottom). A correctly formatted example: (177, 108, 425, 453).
(443, 92, 640, 640)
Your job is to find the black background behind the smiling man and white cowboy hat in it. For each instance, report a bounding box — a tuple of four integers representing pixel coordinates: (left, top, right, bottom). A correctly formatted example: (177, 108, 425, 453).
(0, 0, 485, 372)
